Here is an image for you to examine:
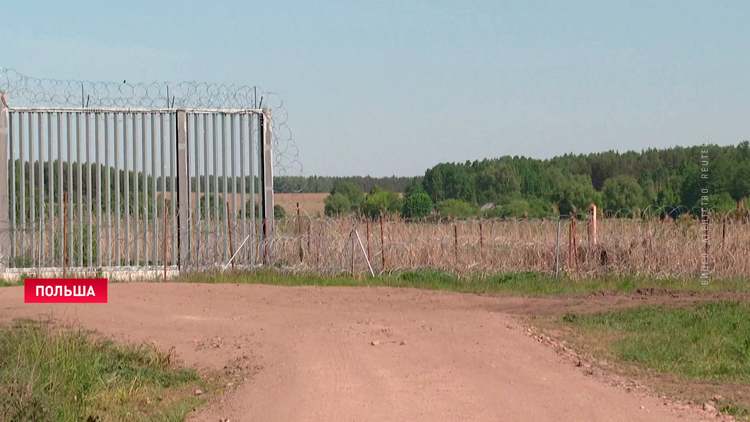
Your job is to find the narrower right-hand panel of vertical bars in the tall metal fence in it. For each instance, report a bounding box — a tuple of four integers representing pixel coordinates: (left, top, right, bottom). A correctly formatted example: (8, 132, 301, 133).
(186, 110, 266, 266)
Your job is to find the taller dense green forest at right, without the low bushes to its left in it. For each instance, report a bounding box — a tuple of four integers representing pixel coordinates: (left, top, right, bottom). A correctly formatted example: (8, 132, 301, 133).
(422, 141, 750, 215)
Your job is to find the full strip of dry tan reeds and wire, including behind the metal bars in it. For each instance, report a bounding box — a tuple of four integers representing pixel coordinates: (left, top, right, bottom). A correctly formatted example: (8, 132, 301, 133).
(4, 203, 750, 278)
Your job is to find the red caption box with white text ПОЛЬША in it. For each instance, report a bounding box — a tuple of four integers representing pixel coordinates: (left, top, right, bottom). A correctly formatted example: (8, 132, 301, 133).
(24, 278, 107, 303)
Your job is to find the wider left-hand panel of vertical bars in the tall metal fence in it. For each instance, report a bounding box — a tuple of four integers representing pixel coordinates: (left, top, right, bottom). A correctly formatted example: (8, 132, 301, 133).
(3, 110, 176, 267)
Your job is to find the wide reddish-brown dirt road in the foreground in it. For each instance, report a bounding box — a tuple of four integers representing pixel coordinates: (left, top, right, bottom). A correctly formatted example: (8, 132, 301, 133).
(0, 283, 710, 422)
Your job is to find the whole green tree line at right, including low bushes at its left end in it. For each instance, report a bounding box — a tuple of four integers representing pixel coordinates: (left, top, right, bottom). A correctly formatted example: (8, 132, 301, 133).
(326, 141, 750, 218)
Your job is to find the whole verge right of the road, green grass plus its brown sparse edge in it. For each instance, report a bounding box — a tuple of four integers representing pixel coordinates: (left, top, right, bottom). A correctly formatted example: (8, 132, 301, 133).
(556, 301, 750, 420)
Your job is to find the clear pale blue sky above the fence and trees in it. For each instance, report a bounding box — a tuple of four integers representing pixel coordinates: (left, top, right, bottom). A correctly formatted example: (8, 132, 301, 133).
(0, 0, 750, 176)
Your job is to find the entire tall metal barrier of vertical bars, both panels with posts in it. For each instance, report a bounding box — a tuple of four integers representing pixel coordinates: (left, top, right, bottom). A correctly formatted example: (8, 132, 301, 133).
(0, 92, 274, 272)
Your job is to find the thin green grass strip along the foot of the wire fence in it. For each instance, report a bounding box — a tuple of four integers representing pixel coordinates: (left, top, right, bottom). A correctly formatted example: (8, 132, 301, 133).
(173, 270, 750, 296)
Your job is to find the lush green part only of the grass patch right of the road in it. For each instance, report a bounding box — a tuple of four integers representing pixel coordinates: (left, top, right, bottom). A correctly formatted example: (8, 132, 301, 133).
(563, 301, 750, 384)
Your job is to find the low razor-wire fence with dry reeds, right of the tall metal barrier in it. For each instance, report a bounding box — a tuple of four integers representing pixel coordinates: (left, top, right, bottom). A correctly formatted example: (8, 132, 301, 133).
(272, 209, 750, 278)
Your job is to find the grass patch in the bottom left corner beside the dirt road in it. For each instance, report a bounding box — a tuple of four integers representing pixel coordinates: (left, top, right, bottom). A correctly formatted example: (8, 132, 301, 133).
(0, 321, 205, 422)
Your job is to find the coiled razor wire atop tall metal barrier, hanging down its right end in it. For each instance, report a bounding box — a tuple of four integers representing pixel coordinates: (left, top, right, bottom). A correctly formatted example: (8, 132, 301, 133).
(0, 67, 303, 199)
